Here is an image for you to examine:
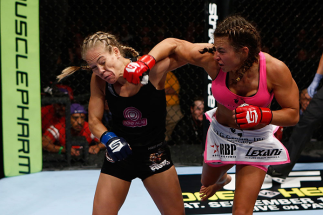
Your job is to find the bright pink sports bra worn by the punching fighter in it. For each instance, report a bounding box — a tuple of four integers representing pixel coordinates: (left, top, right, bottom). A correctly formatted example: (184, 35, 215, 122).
(212, 52, 274, 110)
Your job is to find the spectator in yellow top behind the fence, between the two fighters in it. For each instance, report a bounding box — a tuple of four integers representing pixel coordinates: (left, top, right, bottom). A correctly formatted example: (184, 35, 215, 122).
(165, 72, 183, 143)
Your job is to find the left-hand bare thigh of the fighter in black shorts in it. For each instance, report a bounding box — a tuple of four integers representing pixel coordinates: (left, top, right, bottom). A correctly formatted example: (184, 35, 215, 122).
(93, 173, 131, 215)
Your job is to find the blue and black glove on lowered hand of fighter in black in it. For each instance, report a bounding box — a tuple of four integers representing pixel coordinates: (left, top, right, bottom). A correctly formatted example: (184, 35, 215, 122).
(100, 131, 132, 162)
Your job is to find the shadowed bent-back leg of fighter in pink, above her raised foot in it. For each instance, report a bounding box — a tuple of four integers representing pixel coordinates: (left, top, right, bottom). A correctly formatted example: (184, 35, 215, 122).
(201, 162, 233, 186)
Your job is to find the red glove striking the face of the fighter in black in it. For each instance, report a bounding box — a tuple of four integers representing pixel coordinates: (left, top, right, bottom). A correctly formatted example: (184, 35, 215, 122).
(123, 55, 156, 84)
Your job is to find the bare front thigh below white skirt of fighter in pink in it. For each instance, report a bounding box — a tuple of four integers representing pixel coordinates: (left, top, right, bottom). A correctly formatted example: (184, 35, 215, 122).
(233, 165, 266, 214)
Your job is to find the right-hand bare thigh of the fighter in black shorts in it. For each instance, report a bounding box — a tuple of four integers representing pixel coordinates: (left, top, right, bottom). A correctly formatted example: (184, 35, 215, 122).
(143, 166, 185, 215)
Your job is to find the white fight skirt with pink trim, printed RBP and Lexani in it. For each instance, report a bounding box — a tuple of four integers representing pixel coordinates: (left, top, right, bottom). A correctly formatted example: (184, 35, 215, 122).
(204, 108, 290, 166)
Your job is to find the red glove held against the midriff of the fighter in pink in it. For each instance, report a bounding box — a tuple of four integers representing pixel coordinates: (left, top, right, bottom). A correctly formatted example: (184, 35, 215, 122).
(235, 105, 273, 128)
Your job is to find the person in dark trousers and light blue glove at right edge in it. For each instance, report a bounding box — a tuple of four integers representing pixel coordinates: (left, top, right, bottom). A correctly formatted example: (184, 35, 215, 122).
(267, 54, 323, 183)
